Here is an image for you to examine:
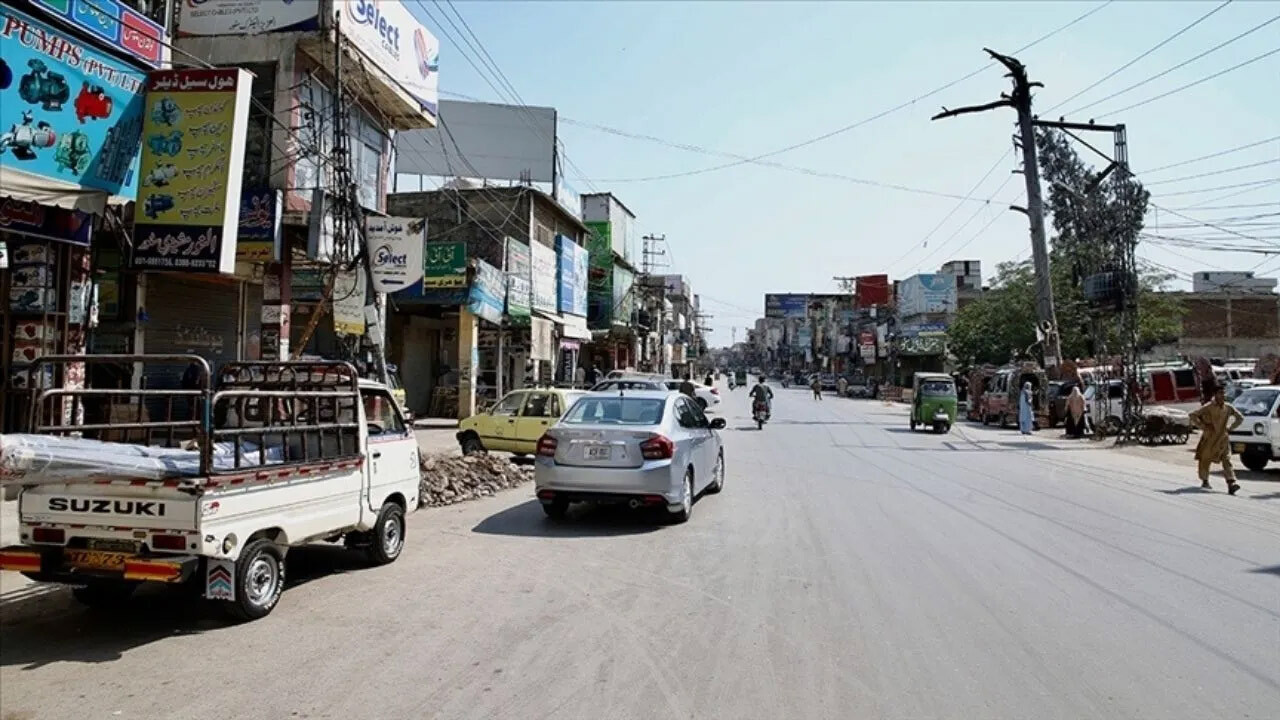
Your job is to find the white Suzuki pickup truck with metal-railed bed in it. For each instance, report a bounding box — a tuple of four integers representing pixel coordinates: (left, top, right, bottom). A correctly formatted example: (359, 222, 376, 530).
(0, 355, 419, 620)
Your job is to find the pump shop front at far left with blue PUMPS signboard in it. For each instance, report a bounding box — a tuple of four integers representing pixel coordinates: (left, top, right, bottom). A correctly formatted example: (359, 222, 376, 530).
(0, 1, 169, 432)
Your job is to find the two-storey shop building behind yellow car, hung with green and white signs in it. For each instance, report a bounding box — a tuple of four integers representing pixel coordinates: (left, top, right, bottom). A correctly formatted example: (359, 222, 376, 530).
(388, 187, 591, 418)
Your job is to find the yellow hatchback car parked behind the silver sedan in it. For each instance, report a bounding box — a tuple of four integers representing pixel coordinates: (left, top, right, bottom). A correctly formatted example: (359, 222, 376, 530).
(457, 388, 586, 455)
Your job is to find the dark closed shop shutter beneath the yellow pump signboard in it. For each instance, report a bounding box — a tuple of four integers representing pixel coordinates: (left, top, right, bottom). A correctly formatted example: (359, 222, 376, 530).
(143, 273, 241, 388)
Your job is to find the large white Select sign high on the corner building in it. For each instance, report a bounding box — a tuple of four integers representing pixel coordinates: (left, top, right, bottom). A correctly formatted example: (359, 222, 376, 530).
(335, 0, 440, 122)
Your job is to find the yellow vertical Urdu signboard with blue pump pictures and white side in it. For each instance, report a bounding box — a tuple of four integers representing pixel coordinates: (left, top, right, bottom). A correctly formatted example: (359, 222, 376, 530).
(131, 68, 253, 273)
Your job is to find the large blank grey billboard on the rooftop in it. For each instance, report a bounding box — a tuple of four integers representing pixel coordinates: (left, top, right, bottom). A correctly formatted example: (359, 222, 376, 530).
(396, 100, 552, 180)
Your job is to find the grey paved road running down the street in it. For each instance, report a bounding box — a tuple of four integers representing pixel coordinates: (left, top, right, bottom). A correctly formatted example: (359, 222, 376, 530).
(0, 389, 1280, 720)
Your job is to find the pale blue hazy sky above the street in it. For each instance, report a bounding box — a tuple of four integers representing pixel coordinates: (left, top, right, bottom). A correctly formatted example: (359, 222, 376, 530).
(404, 0, 1280, 345)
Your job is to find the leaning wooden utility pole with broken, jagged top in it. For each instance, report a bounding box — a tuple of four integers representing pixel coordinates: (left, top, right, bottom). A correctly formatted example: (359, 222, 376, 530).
(932, 47, 1062, 370)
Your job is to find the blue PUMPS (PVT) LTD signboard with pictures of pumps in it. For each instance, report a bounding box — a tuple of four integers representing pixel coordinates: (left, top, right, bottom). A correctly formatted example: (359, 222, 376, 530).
(0, 5, 146, 200)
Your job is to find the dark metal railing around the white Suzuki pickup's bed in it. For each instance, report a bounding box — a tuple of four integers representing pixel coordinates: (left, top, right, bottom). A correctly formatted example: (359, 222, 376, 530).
(29, 355, 360, 475)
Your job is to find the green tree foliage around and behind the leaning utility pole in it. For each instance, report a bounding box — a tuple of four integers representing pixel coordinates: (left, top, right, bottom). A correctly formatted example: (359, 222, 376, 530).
(948, 131, 1181, 364)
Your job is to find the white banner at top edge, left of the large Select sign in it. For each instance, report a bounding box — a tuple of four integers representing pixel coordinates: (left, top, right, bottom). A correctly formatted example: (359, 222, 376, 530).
(178, 0, 320, 36)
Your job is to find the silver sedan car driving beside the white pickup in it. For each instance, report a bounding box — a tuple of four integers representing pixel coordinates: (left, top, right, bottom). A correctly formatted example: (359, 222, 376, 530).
(534, 391, 724, 523)
